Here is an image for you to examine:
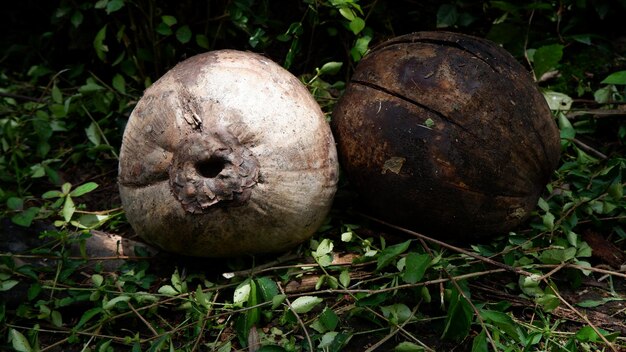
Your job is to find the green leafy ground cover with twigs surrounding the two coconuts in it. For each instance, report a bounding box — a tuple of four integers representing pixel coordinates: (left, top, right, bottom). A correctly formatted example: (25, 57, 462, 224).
(0, 0, 626, 351)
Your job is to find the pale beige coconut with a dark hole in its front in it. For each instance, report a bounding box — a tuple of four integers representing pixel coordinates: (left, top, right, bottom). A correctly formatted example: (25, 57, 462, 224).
(119, 50, 338, 257)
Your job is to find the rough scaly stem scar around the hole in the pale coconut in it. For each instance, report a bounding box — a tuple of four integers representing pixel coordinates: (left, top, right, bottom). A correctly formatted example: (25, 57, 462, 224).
(169, 129, 259, 214)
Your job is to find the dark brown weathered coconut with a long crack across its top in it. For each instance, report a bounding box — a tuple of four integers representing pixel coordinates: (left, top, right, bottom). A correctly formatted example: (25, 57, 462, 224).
(332, 32, 559, 238)
